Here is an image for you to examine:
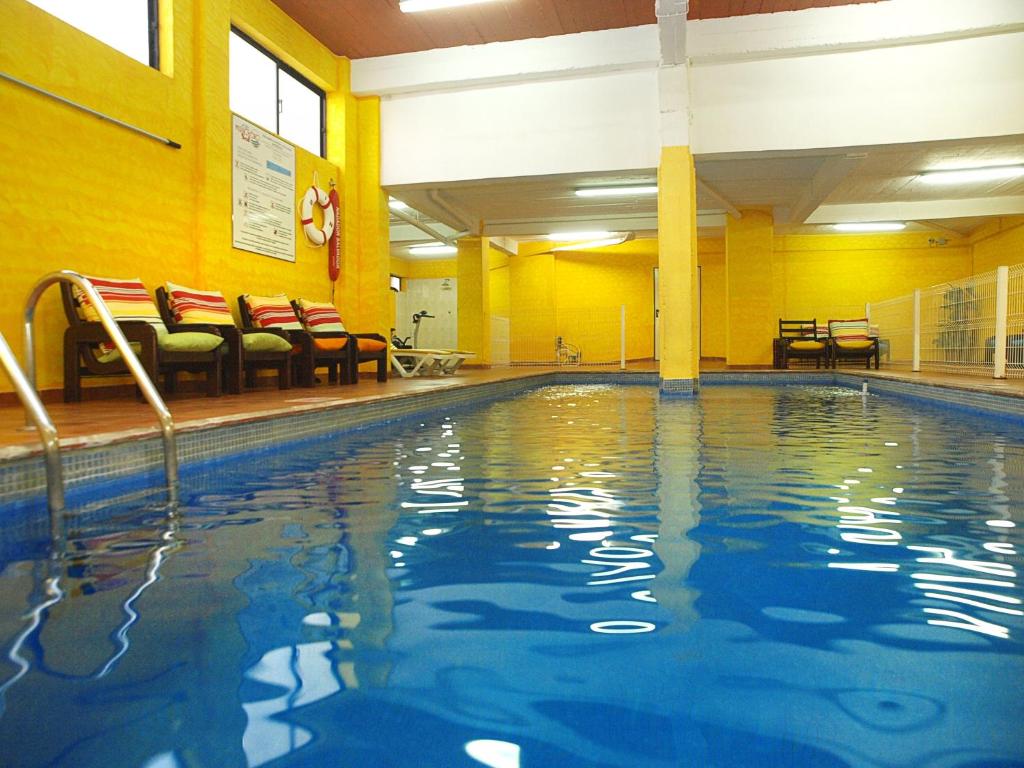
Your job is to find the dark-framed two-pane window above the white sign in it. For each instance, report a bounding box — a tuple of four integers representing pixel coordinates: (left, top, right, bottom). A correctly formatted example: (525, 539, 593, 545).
(230, 30, 327, 157)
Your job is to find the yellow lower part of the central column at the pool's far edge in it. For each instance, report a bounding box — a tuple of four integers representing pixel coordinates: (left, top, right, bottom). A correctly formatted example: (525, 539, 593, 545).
(657, 146, 700, 394)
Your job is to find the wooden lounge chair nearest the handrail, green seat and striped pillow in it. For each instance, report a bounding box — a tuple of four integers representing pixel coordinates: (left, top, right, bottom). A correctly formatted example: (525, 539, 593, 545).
(60, 278, 224, 402)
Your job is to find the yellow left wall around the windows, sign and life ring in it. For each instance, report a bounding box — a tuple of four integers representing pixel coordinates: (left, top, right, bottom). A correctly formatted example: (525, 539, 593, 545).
(0, 0, 388, 390)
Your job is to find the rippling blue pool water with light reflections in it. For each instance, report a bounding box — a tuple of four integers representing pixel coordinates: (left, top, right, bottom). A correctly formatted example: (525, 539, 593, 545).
(0, 386, 1024, 768)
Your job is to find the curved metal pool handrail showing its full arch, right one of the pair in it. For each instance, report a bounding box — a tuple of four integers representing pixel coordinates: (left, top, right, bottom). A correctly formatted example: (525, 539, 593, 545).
(25, 269, 178, 501)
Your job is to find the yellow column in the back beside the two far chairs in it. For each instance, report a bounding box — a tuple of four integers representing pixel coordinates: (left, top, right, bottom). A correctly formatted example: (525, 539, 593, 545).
(725, 210, 778, 366)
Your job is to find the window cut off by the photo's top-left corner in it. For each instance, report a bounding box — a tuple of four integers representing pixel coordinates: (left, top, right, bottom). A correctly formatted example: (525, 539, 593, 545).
(29, 0, 160, 70)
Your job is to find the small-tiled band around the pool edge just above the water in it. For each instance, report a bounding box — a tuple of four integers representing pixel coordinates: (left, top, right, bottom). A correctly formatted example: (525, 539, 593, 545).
(0, 371, 1024, 504)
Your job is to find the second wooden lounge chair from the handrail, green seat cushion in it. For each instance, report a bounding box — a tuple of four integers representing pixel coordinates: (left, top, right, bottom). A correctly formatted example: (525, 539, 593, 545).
(157, 283, 292, 394)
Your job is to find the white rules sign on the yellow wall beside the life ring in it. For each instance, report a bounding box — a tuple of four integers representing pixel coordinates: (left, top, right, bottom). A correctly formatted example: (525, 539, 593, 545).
(231, 115, 295, 261)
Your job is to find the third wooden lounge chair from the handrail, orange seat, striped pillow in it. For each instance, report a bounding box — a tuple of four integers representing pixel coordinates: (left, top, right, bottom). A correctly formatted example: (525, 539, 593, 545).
(239, 294, 355, 387)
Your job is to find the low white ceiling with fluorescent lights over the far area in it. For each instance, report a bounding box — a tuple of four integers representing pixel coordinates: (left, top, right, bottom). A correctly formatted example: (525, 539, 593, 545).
(388, 129, 1024, 257)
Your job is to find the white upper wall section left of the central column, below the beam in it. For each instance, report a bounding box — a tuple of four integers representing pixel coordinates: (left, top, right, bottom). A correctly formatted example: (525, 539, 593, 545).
(381, 69, 660, 186)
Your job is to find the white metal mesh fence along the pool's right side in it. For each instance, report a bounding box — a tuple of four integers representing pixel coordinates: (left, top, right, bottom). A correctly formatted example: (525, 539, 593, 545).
(869, 264, 1024, 379)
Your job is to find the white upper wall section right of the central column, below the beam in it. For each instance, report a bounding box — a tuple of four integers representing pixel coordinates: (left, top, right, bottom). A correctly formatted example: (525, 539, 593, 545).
(690, 32, 1024, 154)
